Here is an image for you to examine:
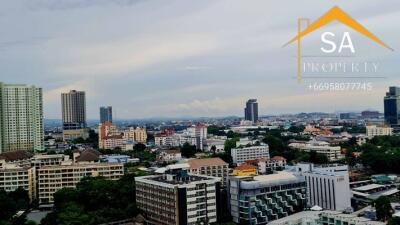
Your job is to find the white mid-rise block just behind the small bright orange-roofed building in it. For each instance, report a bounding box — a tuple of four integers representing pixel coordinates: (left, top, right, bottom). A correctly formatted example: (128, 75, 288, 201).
(231, 145, 269, 165)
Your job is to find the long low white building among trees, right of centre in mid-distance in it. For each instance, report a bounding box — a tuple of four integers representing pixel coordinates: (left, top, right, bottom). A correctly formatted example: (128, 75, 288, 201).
(289, 140, 343, 161)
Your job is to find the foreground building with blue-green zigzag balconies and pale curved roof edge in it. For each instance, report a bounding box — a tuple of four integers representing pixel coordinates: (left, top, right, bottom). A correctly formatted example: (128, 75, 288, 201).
(227, 172, 306, 224)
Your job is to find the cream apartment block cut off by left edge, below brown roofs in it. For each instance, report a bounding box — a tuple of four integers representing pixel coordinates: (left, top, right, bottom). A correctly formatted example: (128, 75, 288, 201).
(0, 160, 36, 200)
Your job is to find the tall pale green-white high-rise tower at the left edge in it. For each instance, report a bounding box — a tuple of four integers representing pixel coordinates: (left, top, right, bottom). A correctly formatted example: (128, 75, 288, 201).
(0, 82, 44, 153)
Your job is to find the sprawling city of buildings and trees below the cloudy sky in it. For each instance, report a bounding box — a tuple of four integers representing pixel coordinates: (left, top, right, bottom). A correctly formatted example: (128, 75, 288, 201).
(0, 83, 400, 225)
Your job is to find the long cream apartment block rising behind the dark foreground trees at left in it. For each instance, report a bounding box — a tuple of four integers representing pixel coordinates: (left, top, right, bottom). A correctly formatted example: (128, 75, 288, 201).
(37, 163, 124, 204)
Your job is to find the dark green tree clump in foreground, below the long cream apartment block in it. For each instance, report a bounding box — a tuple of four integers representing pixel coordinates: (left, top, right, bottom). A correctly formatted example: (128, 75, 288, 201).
(41, 175, 138, 225)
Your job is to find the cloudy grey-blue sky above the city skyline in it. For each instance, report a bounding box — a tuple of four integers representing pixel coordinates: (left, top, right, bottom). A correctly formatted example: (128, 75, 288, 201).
(0, 0, 400, 119)
